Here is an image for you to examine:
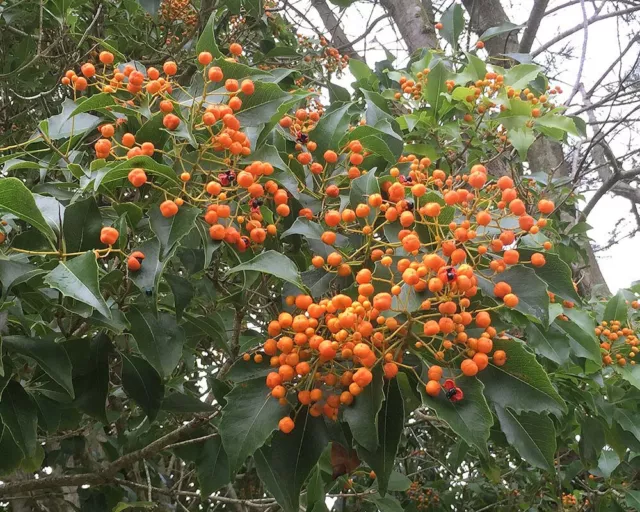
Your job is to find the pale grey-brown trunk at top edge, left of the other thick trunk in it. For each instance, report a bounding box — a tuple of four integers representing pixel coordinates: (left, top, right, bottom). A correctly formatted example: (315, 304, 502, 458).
(380, 0, 438, 53)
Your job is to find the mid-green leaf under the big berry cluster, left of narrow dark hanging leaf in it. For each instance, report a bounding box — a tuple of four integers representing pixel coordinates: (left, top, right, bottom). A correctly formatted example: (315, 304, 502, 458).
(343, 365, 384, 452)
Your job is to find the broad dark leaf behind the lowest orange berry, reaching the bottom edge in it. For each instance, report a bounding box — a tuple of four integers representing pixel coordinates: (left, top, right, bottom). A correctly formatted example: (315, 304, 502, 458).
(254, 410, 329, 512)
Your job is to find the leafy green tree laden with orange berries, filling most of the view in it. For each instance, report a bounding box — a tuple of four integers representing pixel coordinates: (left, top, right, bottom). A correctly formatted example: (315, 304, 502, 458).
(0, 1, 640, 512)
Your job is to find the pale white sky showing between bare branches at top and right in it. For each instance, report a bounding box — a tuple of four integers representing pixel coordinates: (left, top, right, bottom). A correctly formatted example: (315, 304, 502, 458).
(297, 0, 640, 293)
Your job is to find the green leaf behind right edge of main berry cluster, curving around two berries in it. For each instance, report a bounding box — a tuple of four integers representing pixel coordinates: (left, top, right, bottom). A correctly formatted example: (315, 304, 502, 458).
(478, 265, 549, 326)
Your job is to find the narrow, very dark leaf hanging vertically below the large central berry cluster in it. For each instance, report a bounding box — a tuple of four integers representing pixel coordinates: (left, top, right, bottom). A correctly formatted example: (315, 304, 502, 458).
(357, 379, 408, 496)
